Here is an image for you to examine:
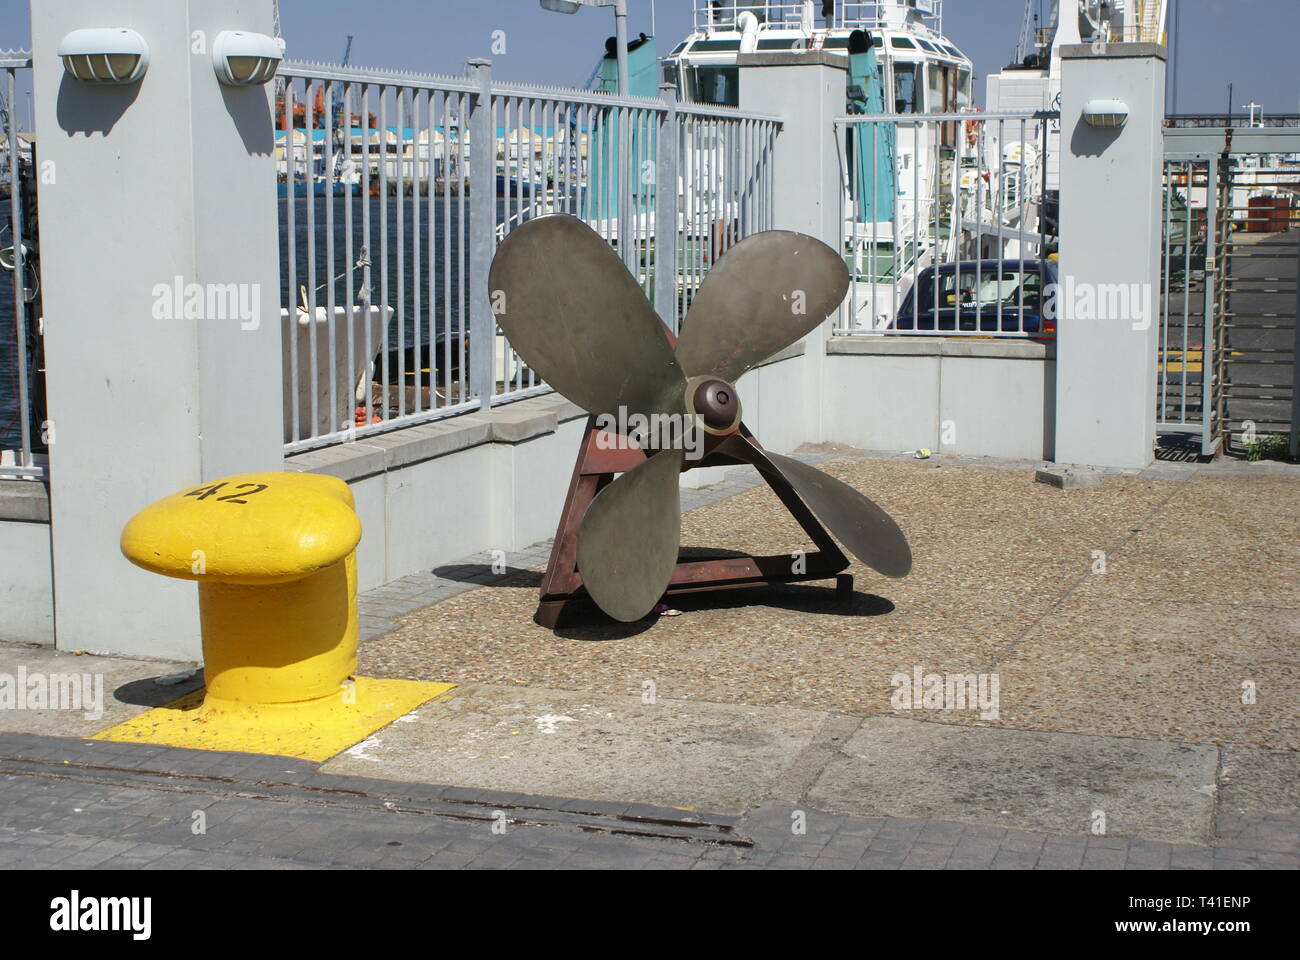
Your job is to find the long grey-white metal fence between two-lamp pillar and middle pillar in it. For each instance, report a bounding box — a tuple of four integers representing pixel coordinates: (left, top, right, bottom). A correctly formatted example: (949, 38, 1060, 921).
(276, 61, 780, 453)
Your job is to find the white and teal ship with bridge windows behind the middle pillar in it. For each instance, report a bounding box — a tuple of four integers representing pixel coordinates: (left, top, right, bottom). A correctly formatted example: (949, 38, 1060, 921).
(664, 0, 982, 329)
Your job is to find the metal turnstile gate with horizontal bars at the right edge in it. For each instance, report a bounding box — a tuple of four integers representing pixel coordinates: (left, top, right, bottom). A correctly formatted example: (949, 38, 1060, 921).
(1156, 127, 1300, 457)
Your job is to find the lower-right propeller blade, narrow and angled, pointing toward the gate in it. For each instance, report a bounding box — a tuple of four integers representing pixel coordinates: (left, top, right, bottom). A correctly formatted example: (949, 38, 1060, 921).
(718, 437, 911, 578)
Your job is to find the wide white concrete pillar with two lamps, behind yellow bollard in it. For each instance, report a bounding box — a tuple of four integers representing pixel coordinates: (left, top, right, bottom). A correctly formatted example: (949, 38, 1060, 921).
(31, 0, 283, 658)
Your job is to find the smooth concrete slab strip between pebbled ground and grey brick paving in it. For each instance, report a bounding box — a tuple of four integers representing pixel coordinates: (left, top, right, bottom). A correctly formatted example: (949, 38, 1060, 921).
(322, 684, 1258, 843)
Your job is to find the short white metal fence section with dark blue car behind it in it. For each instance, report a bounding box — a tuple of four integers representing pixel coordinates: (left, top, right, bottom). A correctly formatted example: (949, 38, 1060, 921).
(835, 113, 1060, 340)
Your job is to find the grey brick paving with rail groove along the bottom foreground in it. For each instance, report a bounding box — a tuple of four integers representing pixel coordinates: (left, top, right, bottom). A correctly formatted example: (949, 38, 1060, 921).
(0, 734, 1300, 870)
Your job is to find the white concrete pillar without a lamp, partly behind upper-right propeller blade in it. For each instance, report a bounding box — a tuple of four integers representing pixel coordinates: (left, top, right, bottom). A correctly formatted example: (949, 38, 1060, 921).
(737, 51, 849, 442)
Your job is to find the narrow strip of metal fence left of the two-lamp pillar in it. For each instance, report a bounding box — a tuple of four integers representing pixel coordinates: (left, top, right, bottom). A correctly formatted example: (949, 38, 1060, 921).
(0, 51, 47, 479)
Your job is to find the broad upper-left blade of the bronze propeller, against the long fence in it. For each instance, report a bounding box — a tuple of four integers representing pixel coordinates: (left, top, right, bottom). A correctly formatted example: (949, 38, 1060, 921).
(488, 215, 685, 415)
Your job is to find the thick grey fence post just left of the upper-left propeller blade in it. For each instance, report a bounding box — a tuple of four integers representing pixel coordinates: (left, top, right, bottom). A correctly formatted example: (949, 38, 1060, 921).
(462, 60, 497, 410)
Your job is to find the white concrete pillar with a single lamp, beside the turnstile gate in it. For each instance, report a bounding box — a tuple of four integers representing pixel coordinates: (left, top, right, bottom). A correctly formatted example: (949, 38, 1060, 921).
(1056, 43, 1165, 468)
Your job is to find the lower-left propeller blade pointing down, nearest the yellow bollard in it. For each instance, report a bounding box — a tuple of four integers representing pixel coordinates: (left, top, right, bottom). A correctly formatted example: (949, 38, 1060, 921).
(577, 450, 684, 623)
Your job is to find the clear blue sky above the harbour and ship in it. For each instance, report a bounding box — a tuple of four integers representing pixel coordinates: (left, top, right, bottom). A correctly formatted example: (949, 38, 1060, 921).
(0, 0, 1300, 120)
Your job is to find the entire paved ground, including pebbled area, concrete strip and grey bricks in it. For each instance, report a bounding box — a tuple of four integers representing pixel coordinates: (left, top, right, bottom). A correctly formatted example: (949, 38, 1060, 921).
(0, 450, 1300, 869)
